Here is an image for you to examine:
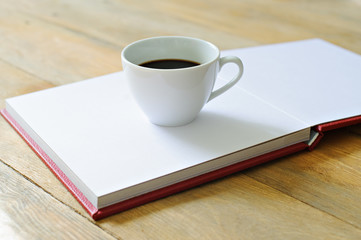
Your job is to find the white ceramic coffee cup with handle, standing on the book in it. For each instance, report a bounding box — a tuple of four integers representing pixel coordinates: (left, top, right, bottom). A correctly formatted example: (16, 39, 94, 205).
(122, 36, 243, 126)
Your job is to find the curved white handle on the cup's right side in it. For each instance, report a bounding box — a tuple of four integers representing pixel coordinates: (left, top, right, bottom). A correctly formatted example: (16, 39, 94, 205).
(207, 56, 243, 102)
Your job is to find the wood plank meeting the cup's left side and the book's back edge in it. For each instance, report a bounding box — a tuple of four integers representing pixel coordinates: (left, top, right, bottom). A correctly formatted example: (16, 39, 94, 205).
(0, 1, 121, 85)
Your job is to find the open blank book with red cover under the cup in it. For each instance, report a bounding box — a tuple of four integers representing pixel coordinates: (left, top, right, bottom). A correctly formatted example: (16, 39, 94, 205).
(1, 39, 361, 219)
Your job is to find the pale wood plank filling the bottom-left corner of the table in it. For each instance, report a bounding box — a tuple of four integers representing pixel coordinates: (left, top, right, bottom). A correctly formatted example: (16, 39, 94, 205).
(0, 161, 115, 239)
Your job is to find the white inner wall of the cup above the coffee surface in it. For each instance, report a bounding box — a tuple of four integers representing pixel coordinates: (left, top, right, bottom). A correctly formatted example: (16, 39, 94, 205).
(123, 36, 219, 65)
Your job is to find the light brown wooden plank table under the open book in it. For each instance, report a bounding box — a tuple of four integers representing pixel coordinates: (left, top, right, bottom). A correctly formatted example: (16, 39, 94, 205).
(0, 0, 361, 239)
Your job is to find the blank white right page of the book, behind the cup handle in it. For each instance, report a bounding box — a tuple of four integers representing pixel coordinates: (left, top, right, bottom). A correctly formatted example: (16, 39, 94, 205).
(221, 39, 361, 126)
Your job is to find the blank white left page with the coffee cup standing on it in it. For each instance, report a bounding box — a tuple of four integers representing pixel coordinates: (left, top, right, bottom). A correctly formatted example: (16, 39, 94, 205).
(7, 72, 307, 204)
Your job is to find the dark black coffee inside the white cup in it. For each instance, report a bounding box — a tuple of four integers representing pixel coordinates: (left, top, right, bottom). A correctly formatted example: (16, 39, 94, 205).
(139, 59, 199, 69)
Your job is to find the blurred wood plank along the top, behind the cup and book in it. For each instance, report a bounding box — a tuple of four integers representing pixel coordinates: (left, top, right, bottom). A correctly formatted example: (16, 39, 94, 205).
(5, 0, 361, 52)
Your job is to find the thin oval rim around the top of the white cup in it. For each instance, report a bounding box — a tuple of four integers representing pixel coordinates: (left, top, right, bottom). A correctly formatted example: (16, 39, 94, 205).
(121, 36, 220, 71)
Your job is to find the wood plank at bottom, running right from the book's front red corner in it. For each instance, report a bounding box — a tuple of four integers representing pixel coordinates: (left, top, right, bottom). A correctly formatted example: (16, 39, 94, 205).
(99, 174, 361, 239)
